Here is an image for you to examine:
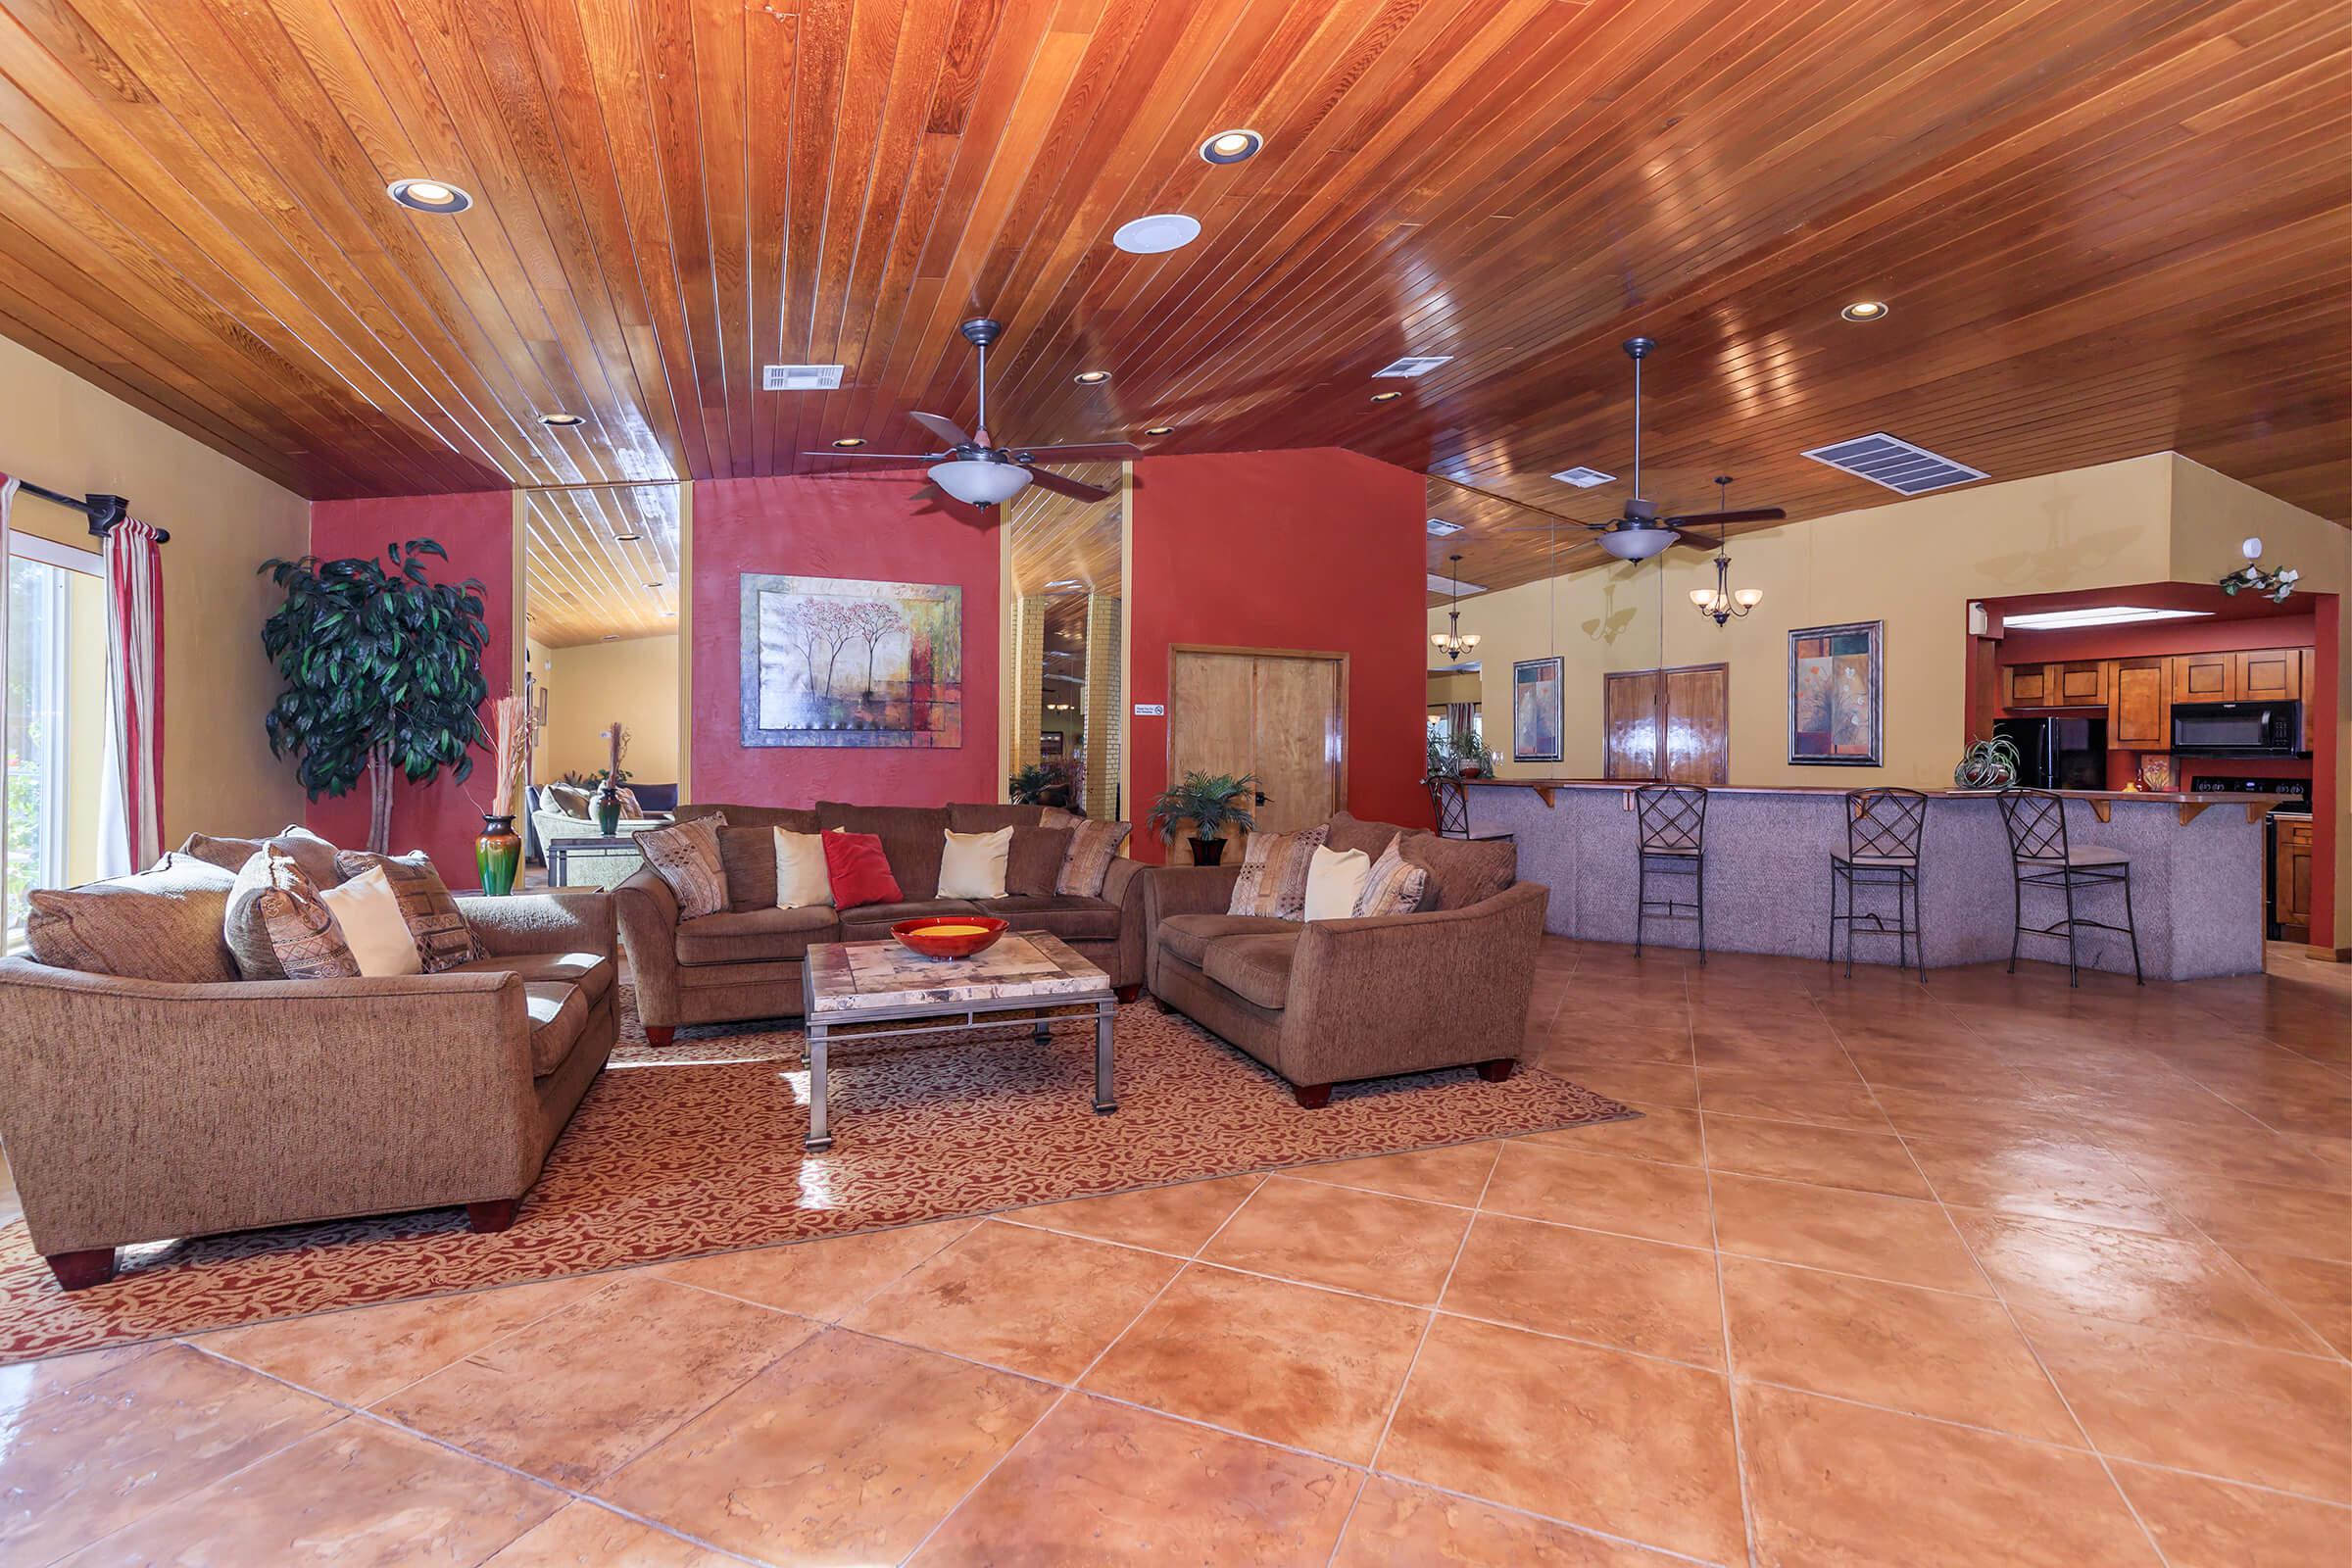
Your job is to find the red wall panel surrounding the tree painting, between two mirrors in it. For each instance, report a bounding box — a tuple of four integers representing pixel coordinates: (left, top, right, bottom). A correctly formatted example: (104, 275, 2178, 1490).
(687, 470, 1004, 807)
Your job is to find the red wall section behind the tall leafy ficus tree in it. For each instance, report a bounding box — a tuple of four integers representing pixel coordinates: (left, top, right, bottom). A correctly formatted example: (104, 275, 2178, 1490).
(306, 489, 517, 889)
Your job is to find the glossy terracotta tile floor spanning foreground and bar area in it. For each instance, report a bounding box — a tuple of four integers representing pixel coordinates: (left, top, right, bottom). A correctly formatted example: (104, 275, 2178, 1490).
(0, 943, 2352, 1568)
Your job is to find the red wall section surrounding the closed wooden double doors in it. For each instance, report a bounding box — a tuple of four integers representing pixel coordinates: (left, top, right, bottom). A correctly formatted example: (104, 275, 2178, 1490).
(1127, 447, 1435, 860)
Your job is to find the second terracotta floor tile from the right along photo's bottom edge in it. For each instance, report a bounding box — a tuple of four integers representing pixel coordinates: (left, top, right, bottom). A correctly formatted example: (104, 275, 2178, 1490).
(1739, 1382, 2159, 1568)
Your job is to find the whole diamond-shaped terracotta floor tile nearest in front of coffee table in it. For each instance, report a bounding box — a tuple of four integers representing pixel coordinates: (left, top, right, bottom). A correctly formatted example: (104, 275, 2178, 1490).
(842, 1222, 1181, 1382)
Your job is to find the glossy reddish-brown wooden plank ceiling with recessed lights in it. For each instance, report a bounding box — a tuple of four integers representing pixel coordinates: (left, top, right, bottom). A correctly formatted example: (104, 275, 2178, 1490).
(0, 0, 2352, 625)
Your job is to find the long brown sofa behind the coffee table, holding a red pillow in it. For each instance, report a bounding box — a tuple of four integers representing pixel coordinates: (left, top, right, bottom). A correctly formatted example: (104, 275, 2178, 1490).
(613, 802, 1143, 1046)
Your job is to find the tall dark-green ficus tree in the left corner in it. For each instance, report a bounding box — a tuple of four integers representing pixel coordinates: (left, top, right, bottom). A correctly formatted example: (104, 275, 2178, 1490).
(261, 538, 489, 854)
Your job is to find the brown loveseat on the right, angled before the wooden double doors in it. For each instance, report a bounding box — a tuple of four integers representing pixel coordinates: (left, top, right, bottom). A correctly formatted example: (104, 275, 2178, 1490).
(1143, 811, 1550, 1109)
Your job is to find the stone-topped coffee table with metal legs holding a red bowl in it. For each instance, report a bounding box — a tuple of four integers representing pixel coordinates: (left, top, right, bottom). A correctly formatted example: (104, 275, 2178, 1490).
(800, 931, 1119, 1152)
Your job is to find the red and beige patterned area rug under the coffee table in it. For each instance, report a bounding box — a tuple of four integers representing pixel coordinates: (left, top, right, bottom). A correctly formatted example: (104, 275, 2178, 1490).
(0, 987, 1637, 1363)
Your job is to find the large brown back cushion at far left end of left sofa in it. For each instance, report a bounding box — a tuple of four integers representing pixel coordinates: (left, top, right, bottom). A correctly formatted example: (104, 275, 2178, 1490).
(24, 851, 237, 985)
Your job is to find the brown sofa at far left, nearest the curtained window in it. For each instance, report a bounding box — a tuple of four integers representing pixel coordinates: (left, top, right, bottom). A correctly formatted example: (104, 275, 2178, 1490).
(0, 894, 616, 1291)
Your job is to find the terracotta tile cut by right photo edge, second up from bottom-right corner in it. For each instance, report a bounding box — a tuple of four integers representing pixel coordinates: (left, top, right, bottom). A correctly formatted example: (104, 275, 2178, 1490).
(2025, 1312, 2352, 1502)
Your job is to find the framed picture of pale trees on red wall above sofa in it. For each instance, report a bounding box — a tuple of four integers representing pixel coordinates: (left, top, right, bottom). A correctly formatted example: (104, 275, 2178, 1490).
(741, 571, 964, 748)
